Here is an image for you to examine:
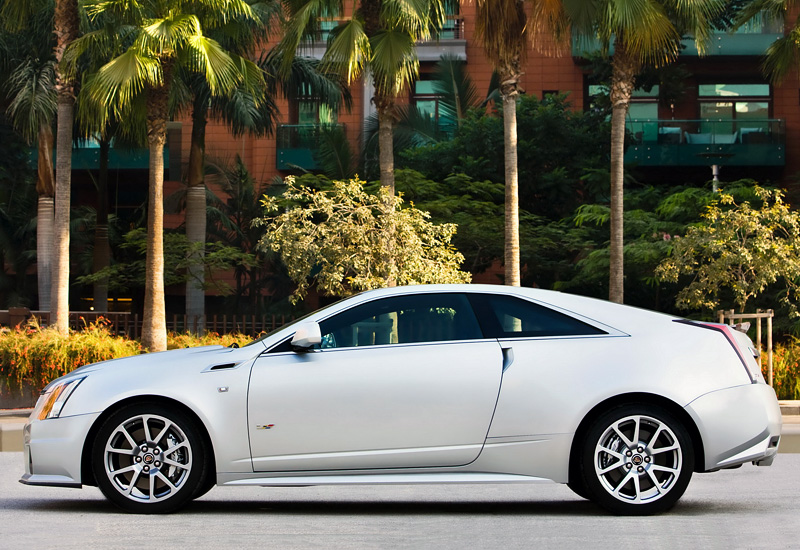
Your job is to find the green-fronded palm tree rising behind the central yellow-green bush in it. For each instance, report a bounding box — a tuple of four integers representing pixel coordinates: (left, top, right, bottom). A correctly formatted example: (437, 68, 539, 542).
(280, 0, 446, 194)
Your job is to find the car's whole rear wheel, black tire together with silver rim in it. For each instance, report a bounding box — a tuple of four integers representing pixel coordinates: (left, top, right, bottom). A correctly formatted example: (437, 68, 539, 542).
(576, 405, 694, 516)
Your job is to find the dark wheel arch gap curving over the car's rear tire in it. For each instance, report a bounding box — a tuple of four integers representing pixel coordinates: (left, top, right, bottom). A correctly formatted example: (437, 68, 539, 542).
(569, 393, 705, 486)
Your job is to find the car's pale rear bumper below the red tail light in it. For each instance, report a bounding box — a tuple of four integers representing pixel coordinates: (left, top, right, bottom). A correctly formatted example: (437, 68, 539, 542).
(686, 384, 782, 471)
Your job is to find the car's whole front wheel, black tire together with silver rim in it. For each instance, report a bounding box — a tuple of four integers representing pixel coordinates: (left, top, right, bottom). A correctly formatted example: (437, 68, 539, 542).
(92, 403, 213, 514)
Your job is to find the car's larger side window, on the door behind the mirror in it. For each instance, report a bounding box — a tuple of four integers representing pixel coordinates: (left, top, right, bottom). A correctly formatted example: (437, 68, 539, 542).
(320, 294, 482, 349)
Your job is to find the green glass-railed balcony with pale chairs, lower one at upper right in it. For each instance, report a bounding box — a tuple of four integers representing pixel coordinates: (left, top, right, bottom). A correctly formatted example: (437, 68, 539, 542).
(625, 119, 786, 166)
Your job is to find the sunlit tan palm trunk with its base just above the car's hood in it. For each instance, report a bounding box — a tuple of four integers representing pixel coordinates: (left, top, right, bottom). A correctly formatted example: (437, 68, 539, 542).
(142, 82, 169, 351)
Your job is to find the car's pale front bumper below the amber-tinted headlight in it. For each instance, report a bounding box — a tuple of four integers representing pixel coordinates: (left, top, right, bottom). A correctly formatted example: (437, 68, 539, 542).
(19, 413, 100, 487)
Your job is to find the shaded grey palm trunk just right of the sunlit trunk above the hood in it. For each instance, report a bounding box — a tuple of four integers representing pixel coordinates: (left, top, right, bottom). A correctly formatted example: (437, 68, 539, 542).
(186, 99, 208, 334)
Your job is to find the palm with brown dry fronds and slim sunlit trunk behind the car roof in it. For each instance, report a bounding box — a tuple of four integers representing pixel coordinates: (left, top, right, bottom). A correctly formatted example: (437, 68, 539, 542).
(475, 0, 566, 286)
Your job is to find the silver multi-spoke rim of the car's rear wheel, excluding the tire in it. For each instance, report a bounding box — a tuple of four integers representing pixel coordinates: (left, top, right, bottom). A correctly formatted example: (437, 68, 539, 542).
(593, 415, 684, 504)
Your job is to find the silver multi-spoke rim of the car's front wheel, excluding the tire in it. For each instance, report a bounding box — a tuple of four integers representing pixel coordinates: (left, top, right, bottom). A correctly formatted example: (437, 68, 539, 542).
(103, 414, 193, 503)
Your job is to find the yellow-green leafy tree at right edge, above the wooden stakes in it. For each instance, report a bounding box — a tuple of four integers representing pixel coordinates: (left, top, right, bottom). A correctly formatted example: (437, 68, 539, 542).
(656, 187, 800, 316)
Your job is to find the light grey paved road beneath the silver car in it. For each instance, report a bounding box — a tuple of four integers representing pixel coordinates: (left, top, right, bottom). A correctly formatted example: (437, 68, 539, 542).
(0, 453, 800, 550)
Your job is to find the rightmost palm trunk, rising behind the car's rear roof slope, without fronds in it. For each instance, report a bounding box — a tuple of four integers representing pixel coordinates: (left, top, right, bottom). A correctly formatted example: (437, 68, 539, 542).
(608, 36, 638, 304)
